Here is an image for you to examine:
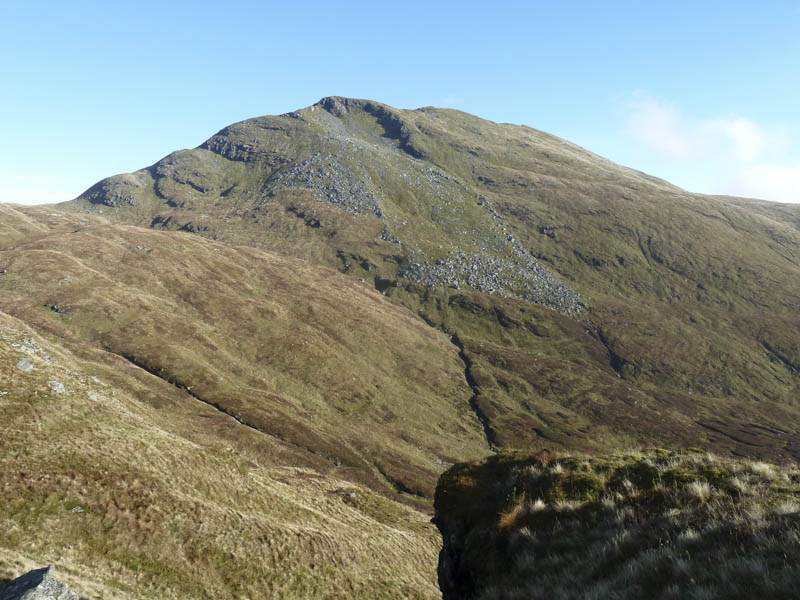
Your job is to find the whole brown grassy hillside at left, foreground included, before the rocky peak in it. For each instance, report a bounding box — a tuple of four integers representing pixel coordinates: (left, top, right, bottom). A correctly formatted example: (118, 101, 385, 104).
(0, 207, 462, 598)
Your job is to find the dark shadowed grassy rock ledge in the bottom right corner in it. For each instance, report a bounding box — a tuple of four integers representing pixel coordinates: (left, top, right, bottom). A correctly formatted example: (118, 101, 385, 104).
(435, 450, 800, 600)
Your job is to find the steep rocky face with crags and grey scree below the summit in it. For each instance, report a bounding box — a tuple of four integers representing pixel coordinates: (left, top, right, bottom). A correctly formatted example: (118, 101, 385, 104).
(65, 98, 581, 313)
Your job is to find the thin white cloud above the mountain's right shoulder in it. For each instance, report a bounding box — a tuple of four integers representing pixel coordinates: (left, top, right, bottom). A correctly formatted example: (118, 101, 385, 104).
(627, 91, 800, 202)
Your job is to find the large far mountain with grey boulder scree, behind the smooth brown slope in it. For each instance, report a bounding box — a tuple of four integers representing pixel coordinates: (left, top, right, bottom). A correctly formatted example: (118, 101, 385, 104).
(62, 98, 800, 460)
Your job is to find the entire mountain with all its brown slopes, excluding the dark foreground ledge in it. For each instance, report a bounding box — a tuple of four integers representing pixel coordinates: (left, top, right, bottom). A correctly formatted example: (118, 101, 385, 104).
(0, 98, 800, 598)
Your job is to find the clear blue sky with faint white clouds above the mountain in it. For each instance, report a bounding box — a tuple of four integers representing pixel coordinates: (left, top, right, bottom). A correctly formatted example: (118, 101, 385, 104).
(0, 0, 800, 203)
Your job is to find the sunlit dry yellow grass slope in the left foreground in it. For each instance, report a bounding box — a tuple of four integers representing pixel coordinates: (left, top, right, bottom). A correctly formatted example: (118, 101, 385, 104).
(0, 313, 438, 598)
